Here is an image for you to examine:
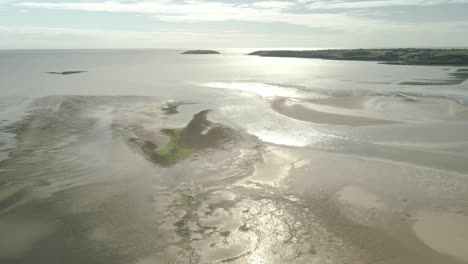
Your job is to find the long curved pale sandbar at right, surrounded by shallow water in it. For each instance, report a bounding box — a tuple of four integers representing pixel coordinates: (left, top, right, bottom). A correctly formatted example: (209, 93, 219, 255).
(268, 94, 468, 126)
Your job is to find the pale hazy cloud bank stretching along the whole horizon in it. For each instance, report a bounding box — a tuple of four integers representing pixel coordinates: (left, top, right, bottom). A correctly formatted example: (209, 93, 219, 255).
(0, 19, 468, 49)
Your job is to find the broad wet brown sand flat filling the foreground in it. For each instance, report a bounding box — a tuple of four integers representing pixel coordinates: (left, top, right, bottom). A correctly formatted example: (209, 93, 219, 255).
(0, 96, 468, 264)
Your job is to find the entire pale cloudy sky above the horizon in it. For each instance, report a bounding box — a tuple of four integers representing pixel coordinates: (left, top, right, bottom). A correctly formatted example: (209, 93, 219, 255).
(0, 0, 468, 49)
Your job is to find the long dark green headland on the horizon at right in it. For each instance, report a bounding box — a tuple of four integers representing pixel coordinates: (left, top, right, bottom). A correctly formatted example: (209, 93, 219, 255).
(248, 49, 468, 66)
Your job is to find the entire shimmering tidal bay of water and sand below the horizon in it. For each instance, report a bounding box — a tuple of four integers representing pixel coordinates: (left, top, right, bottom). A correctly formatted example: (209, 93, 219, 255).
(0, 50, 468, 264)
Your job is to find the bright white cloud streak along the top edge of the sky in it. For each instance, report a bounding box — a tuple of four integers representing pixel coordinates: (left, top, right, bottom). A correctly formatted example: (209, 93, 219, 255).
(11, 0, 468, 30)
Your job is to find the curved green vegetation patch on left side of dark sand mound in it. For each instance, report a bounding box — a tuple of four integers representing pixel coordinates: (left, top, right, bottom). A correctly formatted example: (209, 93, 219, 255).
(142, 129, 193, 166)
